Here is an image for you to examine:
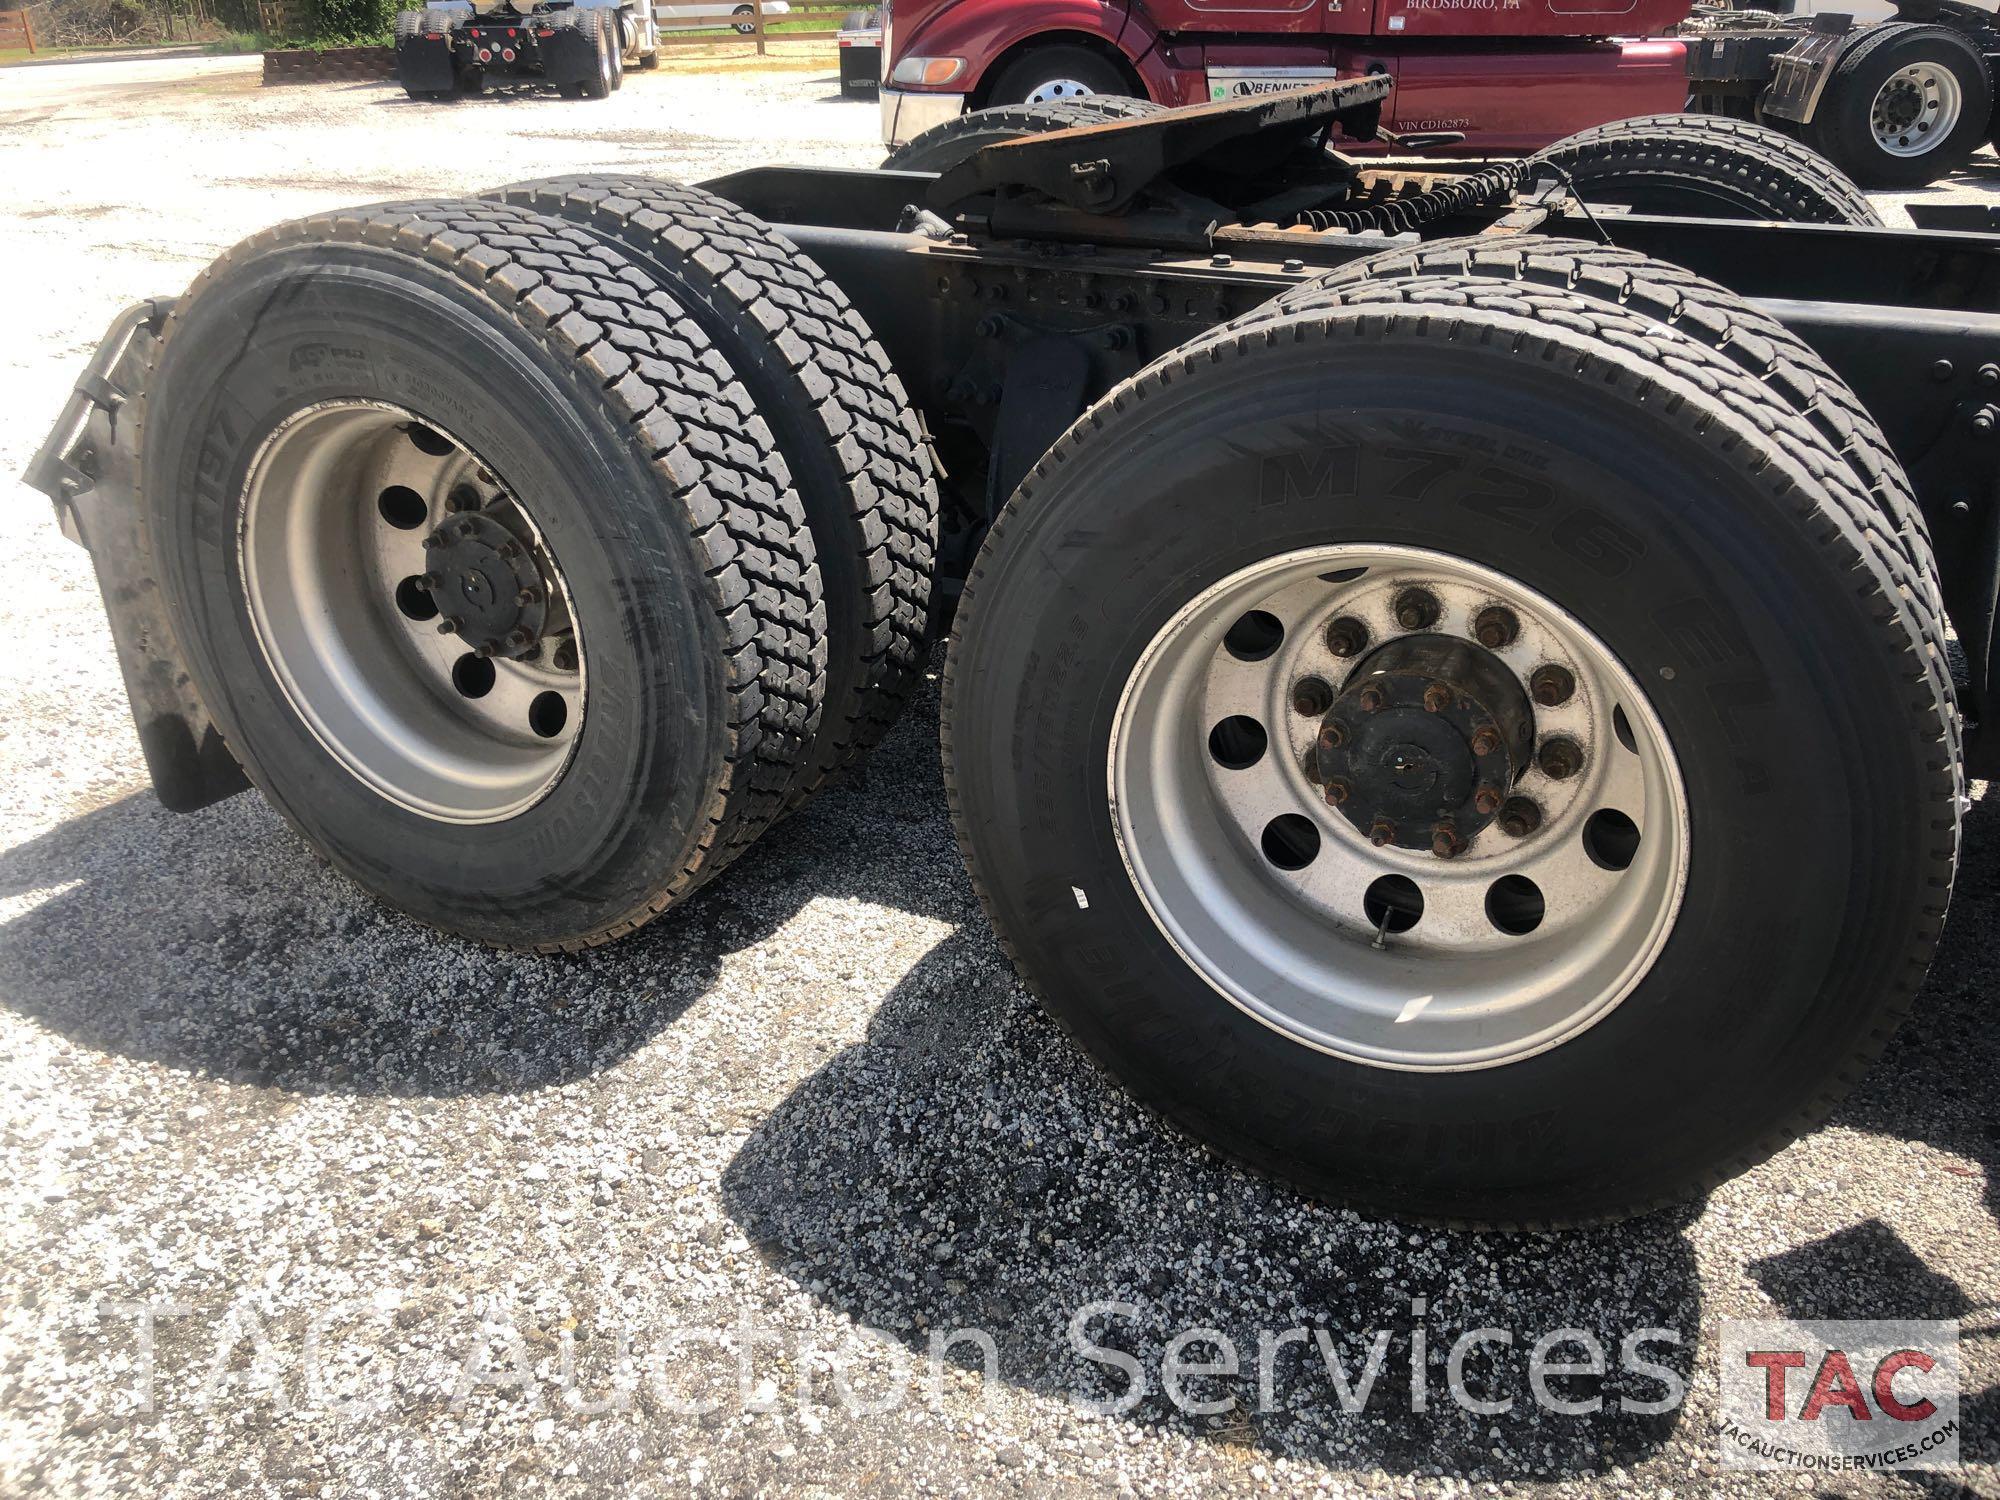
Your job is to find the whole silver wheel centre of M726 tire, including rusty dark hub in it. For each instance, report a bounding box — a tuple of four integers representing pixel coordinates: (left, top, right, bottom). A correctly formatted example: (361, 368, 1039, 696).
(1108, 542, 1690, 1070)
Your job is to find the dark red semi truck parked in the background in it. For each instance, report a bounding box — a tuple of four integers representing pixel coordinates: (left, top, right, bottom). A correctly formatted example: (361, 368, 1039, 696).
(882, 0, 2000, 188)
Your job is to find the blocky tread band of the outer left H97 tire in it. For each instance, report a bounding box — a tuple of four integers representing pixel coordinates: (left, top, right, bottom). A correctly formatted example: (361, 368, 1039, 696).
(140, 200, 826, 952)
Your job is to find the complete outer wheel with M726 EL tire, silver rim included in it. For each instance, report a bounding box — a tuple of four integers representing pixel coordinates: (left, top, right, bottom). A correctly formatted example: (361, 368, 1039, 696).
(944, 276, 1962, 1226)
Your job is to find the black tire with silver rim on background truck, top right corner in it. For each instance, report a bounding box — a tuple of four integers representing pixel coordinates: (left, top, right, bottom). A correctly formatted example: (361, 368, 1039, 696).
(1806, 24, 1994, 188)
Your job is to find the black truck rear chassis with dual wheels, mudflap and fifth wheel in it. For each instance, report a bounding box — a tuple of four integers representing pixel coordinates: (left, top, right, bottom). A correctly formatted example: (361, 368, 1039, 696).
(30, 88, 2000, 1224)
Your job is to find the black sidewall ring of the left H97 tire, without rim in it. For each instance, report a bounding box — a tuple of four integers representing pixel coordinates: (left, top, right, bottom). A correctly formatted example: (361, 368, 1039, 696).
(144, 246, 724, 946)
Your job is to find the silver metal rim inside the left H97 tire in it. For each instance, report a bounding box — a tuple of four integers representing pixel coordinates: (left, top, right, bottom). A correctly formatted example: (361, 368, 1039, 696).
(238, 400, 584, 824)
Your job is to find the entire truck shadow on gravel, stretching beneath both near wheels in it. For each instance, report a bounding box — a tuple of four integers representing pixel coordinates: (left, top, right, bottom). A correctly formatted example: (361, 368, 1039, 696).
(0, 694, 2000, 1480)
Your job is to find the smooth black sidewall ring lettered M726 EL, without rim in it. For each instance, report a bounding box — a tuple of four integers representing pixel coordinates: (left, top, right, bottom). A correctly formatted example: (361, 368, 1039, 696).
(946, 338, 1922, 1218)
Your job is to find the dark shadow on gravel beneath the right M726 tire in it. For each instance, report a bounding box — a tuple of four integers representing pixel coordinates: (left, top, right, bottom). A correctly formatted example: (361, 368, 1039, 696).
(724, 926, 1702, 1480)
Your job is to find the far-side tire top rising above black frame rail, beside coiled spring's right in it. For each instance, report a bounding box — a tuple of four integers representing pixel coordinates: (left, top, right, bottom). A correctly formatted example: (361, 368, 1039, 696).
(1528, 114, 1882, 224)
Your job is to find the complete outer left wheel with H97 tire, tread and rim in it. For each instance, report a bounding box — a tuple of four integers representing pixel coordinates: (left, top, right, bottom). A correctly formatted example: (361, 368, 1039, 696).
(140, 202, 826, 950)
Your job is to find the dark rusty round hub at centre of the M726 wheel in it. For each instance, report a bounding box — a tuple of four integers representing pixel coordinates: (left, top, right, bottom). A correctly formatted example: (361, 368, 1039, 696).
(1314, 634, 1534, 856)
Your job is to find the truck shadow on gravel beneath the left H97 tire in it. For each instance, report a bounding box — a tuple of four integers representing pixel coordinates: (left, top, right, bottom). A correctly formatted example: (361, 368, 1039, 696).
(0, 692, 976, 1098)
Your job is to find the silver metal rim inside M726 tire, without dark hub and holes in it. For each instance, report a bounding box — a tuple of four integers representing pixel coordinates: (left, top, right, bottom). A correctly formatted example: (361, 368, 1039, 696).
(1110, 544, 1688, 1070)
